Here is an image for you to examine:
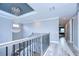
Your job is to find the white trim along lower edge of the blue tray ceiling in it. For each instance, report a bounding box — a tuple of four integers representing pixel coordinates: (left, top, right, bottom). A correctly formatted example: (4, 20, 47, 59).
(0, 10, 37, 19)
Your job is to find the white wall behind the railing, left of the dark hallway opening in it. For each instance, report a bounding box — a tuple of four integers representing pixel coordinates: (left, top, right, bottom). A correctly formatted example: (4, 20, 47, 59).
(25, 18, 59, 42)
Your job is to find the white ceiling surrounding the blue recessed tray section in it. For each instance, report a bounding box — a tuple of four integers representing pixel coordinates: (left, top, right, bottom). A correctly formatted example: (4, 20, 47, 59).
(0, 3, 77, 23)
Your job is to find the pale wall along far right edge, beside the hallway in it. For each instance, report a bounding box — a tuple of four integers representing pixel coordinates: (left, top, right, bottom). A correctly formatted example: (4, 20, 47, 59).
(71, 12, 79, 50)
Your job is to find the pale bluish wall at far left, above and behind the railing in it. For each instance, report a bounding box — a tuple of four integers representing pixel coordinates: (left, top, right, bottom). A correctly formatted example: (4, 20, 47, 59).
(0, 16, 12, 55)
